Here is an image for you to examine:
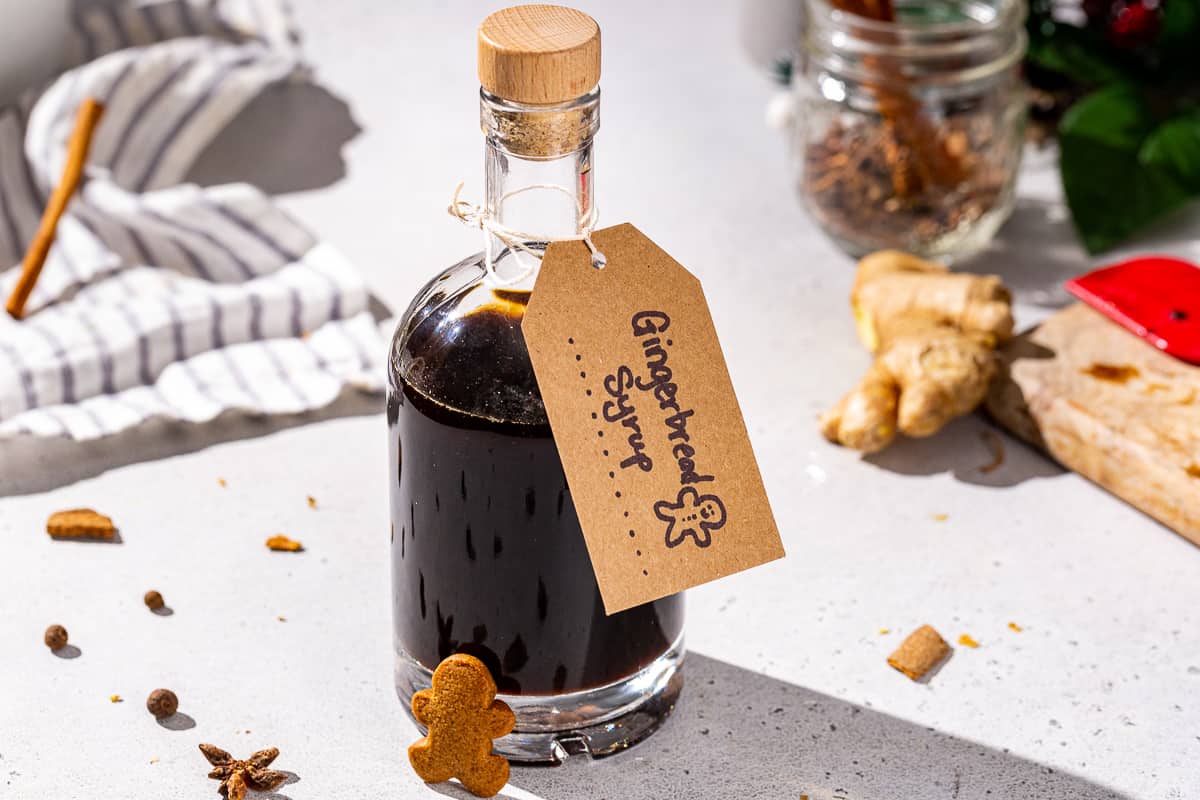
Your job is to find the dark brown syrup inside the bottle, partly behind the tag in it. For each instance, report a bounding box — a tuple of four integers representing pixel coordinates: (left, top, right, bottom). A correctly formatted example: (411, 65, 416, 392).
(388, 291, 683, 694)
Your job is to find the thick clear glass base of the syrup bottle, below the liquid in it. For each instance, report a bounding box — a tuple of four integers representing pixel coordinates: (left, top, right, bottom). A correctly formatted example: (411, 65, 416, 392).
(396, 636, 684, 764)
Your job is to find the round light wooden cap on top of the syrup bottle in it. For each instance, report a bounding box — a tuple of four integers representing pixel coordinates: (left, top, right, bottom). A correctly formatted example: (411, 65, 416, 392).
(479, 5, 600, 106)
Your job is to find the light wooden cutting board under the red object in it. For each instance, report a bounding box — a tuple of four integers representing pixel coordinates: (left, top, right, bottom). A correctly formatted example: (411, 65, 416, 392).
(986, 303, 1200, 545)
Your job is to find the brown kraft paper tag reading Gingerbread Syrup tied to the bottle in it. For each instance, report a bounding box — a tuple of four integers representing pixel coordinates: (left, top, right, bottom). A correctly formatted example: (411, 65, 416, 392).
(522, 224, 784, 614)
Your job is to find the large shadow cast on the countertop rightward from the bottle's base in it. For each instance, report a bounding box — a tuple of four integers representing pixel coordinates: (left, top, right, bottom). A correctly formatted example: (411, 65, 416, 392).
(504, 654, 1130, 800)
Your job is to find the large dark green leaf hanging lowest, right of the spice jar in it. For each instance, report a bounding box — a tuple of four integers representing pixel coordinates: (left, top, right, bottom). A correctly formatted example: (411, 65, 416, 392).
(1058, 84, 1192, 253)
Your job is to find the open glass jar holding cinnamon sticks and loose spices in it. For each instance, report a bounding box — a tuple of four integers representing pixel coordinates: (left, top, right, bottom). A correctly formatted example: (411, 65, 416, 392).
(794, 0, 1027, 260)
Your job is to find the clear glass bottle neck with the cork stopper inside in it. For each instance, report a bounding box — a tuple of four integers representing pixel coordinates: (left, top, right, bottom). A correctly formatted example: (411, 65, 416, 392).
(480, 90, 600, 288)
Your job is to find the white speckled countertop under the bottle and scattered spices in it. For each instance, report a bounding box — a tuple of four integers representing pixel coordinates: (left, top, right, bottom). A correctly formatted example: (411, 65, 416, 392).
(0, 0, 1200, 800)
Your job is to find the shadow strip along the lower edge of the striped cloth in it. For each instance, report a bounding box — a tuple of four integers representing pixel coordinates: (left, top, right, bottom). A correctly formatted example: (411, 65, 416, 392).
(0, 387, 384, 497)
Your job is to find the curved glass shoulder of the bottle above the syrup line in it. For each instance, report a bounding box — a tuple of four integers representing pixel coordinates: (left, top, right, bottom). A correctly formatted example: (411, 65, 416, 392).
(388, 253, 546, 426)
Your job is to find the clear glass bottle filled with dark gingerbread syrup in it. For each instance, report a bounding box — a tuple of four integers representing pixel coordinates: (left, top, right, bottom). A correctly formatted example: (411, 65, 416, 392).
(388, 6, 683, 762)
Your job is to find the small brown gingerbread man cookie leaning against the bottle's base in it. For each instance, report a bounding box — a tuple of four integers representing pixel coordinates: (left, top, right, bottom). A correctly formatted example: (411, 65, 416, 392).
(408, 652, 516, 798)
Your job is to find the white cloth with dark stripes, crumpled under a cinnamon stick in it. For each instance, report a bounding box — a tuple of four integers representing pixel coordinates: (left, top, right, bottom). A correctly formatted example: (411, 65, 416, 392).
(0, 0, 385, 439)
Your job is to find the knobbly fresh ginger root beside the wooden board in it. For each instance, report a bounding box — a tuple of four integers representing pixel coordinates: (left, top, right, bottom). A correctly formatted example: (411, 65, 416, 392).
(821, 249, 1013, 452)
